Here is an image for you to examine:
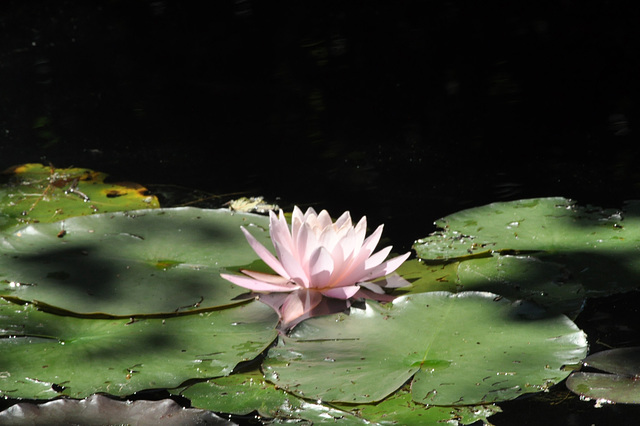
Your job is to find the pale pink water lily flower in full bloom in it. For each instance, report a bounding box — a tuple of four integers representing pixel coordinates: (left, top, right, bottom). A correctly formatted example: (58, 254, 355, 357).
(221, 207, 410, 329)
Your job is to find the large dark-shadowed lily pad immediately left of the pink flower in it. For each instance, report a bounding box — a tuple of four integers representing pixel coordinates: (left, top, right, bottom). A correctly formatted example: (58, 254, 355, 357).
(0, 207, 271, 317)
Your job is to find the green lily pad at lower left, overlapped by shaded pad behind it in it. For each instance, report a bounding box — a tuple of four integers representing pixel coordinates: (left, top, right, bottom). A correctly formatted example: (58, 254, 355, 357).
(0, 300, 278, 399)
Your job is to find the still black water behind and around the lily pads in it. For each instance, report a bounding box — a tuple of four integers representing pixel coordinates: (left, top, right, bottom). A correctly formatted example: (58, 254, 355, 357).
(0, 0, 640, 425)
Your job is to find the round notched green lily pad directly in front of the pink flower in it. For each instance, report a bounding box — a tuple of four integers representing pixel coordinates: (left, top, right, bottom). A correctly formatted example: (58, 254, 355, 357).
(263, 292, 587, 405)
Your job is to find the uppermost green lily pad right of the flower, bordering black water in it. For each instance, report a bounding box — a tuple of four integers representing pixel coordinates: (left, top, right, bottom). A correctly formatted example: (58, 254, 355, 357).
(414, 198, 640, 299)
